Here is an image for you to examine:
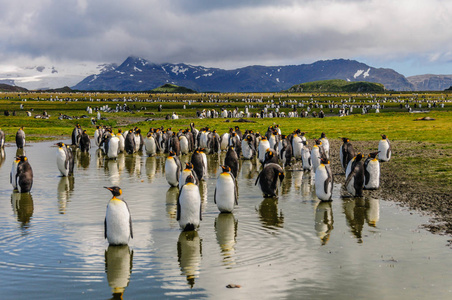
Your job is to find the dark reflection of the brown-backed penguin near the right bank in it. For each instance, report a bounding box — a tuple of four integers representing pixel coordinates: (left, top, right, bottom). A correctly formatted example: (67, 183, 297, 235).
(342, 198, 366, 243)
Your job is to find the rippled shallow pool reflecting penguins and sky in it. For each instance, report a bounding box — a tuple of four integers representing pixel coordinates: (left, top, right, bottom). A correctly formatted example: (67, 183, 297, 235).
(0, 142, 452, 299)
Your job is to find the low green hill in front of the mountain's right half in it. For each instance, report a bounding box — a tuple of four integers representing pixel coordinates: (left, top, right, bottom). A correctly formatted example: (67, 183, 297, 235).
(286, 79, 385, 93)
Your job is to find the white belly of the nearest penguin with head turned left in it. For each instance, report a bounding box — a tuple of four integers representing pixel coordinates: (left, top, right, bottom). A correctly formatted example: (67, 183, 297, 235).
(105, 200, 130, 245)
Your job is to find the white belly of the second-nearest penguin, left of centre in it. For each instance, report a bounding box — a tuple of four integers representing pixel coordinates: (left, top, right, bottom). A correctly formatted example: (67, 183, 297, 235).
(179, 183, 201, 229)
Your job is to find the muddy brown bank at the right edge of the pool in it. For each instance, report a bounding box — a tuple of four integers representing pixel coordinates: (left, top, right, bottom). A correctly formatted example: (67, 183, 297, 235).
(330, 140, 452, 244)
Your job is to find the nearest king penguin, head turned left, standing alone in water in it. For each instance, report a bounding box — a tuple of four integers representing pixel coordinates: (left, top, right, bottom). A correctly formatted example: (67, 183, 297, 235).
(104, 186, 133, 245)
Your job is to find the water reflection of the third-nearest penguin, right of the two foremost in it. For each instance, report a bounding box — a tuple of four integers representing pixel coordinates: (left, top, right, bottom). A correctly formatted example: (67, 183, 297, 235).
(215, 213, 238, 266)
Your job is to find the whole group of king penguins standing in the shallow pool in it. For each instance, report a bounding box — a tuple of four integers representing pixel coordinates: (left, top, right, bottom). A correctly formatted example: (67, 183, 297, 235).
(0, 123, 391, 245)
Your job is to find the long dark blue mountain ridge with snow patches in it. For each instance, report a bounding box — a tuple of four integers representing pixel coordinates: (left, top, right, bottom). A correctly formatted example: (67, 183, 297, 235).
(73, 56, 413, 92)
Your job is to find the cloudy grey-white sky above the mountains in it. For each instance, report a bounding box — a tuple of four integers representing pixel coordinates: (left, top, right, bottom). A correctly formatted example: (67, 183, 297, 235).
(0, 0, 452, 86)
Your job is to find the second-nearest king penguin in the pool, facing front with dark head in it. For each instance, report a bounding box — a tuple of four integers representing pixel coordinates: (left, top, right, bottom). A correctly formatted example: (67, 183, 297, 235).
(176, 175, 202, 231)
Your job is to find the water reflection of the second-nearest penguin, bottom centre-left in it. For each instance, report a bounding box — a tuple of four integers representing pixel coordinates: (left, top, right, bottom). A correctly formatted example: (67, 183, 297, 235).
(177, 230, 202, 288)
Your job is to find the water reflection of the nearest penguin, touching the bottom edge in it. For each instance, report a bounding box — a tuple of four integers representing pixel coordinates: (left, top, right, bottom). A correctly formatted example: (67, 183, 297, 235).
(105, 245, 133, 299)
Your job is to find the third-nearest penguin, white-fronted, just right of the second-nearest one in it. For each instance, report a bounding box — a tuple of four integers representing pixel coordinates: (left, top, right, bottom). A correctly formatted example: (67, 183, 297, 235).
(213, 165, 238, 213)
